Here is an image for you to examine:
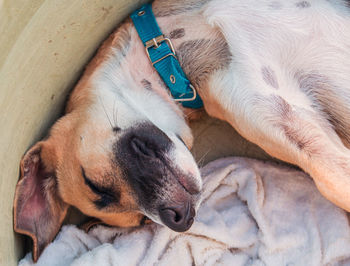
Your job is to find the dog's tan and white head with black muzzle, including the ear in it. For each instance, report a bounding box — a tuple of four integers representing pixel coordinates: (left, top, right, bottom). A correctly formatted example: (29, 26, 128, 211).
(14, 42, 201, 260)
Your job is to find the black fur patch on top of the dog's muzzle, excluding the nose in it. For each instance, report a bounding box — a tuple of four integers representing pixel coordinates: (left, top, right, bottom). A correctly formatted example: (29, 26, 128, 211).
(113, 124, 173, 209)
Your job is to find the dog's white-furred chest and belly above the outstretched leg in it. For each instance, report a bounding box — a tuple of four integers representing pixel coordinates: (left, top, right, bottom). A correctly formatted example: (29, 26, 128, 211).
(205, 1, 350, 135)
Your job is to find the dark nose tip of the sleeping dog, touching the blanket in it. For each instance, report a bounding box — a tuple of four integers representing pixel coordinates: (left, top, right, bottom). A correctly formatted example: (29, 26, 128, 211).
(159, 204, 196, 232)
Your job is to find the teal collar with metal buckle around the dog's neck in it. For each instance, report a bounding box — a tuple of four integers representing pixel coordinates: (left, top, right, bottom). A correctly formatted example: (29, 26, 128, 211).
(131, 4, 203, 108)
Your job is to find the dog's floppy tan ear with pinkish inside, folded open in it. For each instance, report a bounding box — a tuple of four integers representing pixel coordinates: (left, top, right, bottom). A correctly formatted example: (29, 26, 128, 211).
(14, 141, 68, 262)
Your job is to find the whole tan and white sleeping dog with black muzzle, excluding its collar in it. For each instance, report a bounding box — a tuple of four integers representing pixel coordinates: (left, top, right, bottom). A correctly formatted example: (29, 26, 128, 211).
(14, 0, 350, 260)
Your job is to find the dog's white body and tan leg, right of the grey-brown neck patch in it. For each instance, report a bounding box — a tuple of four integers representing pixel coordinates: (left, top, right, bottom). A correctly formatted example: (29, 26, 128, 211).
(200, 1, 350, 210)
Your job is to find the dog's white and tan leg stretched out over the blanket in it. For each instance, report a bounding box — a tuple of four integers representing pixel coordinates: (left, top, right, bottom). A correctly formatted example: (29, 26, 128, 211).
(209, 77, 350, 211)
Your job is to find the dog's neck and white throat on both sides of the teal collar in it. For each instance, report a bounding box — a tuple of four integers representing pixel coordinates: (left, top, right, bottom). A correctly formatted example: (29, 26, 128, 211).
(67, 1, 231, 146)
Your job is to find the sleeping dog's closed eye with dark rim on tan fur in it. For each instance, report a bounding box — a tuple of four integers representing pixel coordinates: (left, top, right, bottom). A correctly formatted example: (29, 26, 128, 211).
(81, 167, 120, 209)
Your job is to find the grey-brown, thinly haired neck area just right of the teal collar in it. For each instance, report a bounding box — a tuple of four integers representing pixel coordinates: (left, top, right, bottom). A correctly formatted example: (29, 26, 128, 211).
(153, 0, 231, 109)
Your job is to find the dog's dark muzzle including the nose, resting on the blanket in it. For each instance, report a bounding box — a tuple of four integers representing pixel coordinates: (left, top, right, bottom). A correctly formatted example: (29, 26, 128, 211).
(114, 123, 200, 232)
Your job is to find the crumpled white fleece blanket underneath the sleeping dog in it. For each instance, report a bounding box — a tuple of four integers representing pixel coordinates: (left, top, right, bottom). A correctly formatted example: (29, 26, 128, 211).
(19, 158, 350, 266)
